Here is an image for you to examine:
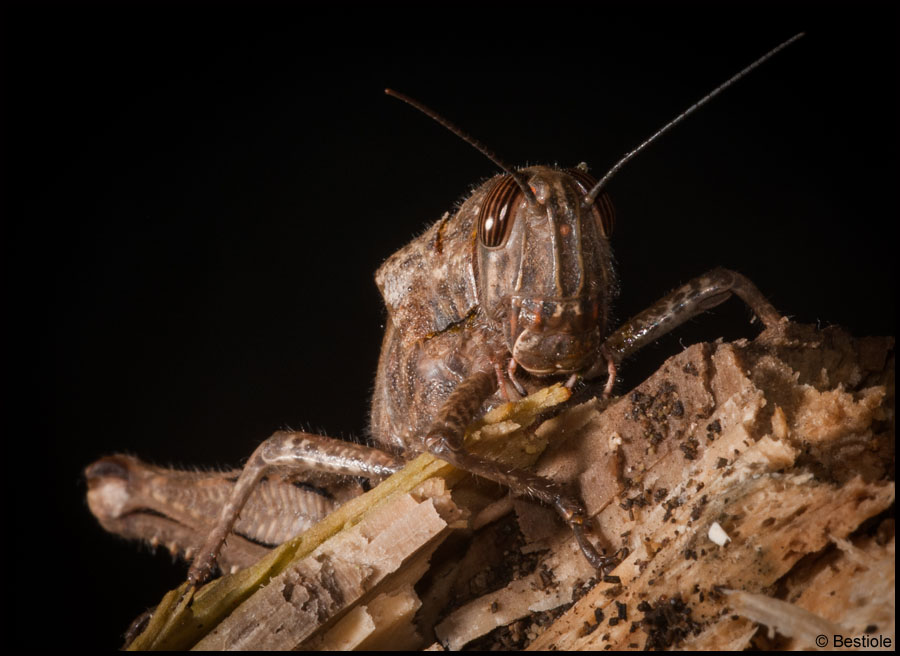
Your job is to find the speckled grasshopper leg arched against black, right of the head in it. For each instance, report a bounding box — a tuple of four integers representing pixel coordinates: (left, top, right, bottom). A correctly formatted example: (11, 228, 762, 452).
(601, 268, 781, 363)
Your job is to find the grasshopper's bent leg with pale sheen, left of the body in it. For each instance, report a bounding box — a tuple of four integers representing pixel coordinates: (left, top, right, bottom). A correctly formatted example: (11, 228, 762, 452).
(188, 431, 403, 585)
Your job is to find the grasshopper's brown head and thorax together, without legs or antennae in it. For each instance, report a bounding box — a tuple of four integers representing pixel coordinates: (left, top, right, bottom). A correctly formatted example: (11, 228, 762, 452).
(371, 166, 615, 453)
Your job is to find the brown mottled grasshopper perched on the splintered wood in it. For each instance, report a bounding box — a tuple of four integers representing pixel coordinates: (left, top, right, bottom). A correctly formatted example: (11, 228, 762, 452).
(88, 166, 780, 583)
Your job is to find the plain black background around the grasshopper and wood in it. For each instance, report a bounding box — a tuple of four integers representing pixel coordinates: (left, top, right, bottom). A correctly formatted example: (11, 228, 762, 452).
(2, 2, 898, 648)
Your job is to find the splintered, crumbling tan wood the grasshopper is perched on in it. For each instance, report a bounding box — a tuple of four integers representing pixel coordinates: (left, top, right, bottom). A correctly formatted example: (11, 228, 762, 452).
(126, 322, 894, 650)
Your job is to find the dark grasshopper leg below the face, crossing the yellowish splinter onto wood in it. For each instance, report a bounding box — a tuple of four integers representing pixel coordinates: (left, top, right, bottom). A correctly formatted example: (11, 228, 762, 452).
(425, 371, 616, 572)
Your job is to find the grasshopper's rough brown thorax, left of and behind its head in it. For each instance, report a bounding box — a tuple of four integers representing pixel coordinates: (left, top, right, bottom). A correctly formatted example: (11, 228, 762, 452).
(370, 182, 502, 453)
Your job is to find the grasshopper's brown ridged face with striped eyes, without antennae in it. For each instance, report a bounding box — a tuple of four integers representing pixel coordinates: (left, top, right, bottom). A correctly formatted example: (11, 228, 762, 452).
(477, 166, 614, 375)
